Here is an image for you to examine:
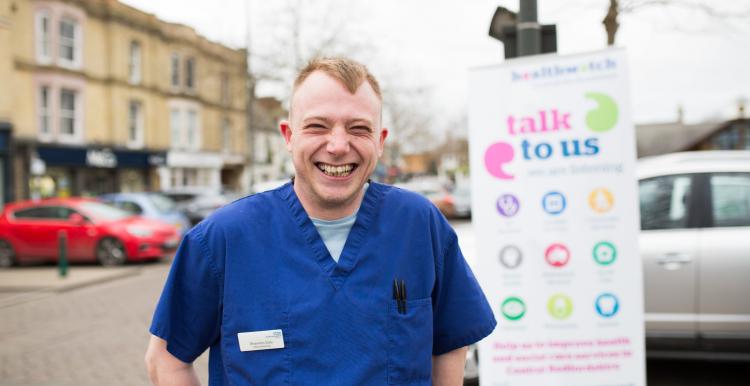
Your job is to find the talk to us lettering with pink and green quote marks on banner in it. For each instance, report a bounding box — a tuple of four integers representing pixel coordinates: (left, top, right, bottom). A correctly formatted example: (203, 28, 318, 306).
(484, 92, 619, 180)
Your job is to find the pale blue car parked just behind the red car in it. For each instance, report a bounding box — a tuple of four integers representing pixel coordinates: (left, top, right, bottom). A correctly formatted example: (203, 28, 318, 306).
(99, 192, 192, 235)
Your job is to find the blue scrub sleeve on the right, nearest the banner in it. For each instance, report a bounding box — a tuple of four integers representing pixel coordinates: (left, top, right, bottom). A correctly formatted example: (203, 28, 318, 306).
(432, 232, 497, 355)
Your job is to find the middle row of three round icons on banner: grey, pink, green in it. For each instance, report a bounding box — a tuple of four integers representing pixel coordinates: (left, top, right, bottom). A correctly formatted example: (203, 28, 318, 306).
(499, 241, 617, 269)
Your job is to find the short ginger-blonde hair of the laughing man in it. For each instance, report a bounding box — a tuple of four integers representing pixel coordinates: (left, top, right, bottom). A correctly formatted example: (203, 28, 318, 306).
(292, 57, 383, 101)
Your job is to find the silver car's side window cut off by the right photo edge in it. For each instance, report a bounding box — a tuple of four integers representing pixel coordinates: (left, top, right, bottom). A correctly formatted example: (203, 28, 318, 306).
(711, 173, 750, 227)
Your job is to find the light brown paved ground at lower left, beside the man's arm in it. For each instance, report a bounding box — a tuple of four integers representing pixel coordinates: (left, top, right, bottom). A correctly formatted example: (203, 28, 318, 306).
(0, 262, 208, 386)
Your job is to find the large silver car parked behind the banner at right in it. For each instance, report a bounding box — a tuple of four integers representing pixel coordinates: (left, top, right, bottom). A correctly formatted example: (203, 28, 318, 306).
(638, 151, 750, 359)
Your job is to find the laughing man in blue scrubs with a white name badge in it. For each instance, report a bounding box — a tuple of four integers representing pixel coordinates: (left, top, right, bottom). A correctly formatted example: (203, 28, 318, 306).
(146, 58, 496, 385)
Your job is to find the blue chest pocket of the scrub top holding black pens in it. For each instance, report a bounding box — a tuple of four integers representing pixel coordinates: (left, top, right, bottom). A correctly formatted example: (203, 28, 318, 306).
(387, 298, 432, 385)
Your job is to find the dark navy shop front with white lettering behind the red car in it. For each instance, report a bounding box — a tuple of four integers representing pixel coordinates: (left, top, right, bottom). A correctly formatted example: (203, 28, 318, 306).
(29, 145, 167, 198)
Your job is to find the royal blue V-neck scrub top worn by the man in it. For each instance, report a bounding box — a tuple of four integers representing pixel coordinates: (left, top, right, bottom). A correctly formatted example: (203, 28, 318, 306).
(150, 183, 496, 385)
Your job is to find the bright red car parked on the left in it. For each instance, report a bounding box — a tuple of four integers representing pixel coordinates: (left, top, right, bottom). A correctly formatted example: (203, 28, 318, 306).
(0, 198, 180, 267)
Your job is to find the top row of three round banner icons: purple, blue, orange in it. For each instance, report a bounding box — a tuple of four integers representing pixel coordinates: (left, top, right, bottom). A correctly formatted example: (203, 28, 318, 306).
(495, 188, 615, 217)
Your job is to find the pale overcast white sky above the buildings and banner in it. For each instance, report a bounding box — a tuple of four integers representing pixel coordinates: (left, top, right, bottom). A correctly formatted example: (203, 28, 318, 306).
(122, 0, 750, 131)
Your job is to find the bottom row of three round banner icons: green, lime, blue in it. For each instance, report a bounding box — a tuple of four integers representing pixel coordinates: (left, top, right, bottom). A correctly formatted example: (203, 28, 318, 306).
(500, 292, 620, 321)
